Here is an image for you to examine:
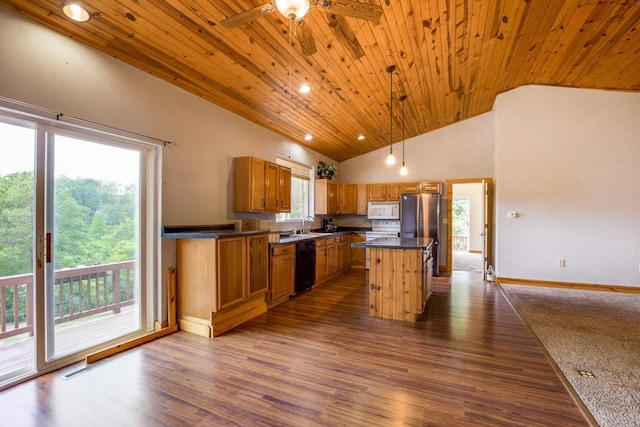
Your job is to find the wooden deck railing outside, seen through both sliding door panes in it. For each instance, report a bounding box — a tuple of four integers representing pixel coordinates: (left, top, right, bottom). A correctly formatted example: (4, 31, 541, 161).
(0, 261, 137, 339)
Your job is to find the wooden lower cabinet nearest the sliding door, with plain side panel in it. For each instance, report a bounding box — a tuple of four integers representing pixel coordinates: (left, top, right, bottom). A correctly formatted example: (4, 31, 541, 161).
(176, 234, 269, 337)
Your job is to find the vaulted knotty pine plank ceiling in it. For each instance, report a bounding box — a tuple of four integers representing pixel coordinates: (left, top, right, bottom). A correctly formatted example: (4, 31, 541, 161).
(0, 0, 640, 161)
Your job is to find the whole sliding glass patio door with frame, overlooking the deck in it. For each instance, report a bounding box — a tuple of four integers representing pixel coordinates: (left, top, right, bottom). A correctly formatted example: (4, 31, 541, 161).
(0, 116, 156, 386)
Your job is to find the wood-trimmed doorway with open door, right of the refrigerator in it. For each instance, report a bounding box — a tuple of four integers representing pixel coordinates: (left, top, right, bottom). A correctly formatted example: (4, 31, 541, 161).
(447, 178, 492, 276)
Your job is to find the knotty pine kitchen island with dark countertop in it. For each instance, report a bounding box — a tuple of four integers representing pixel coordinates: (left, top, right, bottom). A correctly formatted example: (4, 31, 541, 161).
(351, 237, 433, 322)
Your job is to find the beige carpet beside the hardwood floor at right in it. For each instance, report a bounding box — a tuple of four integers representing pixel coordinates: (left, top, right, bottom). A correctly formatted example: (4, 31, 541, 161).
(501, 284, 640, 427)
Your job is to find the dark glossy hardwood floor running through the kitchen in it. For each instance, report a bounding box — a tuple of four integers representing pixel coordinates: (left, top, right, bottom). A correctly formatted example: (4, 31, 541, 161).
(0, 270, 588, 426)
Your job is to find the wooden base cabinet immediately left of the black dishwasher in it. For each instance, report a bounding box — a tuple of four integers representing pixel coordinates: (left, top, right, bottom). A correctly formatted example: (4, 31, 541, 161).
(269, 244, 296, 307)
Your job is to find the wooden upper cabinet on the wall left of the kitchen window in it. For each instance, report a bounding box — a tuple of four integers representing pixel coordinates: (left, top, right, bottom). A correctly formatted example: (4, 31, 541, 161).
(233, 157, 291, 212)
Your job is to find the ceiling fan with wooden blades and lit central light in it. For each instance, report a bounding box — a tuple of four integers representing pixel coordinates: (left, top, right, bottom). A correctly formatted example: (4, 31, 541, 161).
(220, 0, 382, 59)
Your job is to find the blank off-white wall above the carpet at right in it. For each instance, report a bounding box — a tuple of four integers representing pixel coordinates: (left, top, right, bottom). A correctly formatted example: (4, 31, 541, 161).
(494, 86, 640, 286)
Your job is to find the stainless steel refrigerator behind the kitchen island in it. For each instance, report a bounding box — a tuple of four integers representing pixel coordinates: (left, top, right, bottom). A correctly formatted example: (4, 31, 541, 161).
(400, 194, 440, 276)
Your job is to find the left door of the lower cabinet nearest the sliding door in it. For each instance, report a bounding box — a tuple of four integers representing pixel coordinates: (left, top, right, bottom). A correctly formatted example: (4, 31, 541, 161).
(216, 237, 247, 310)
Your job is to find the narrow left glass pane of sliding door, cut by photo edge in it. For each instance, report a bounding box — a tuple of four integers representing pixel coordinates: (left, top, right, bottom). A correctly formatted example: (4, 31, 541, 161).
(0, 118, 36, 384)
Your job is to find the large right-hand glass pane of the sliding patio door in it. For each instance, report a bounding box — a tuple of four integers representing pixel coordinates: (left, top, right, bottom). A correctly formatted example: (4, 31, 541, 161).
(45, 134, 141, 360)
